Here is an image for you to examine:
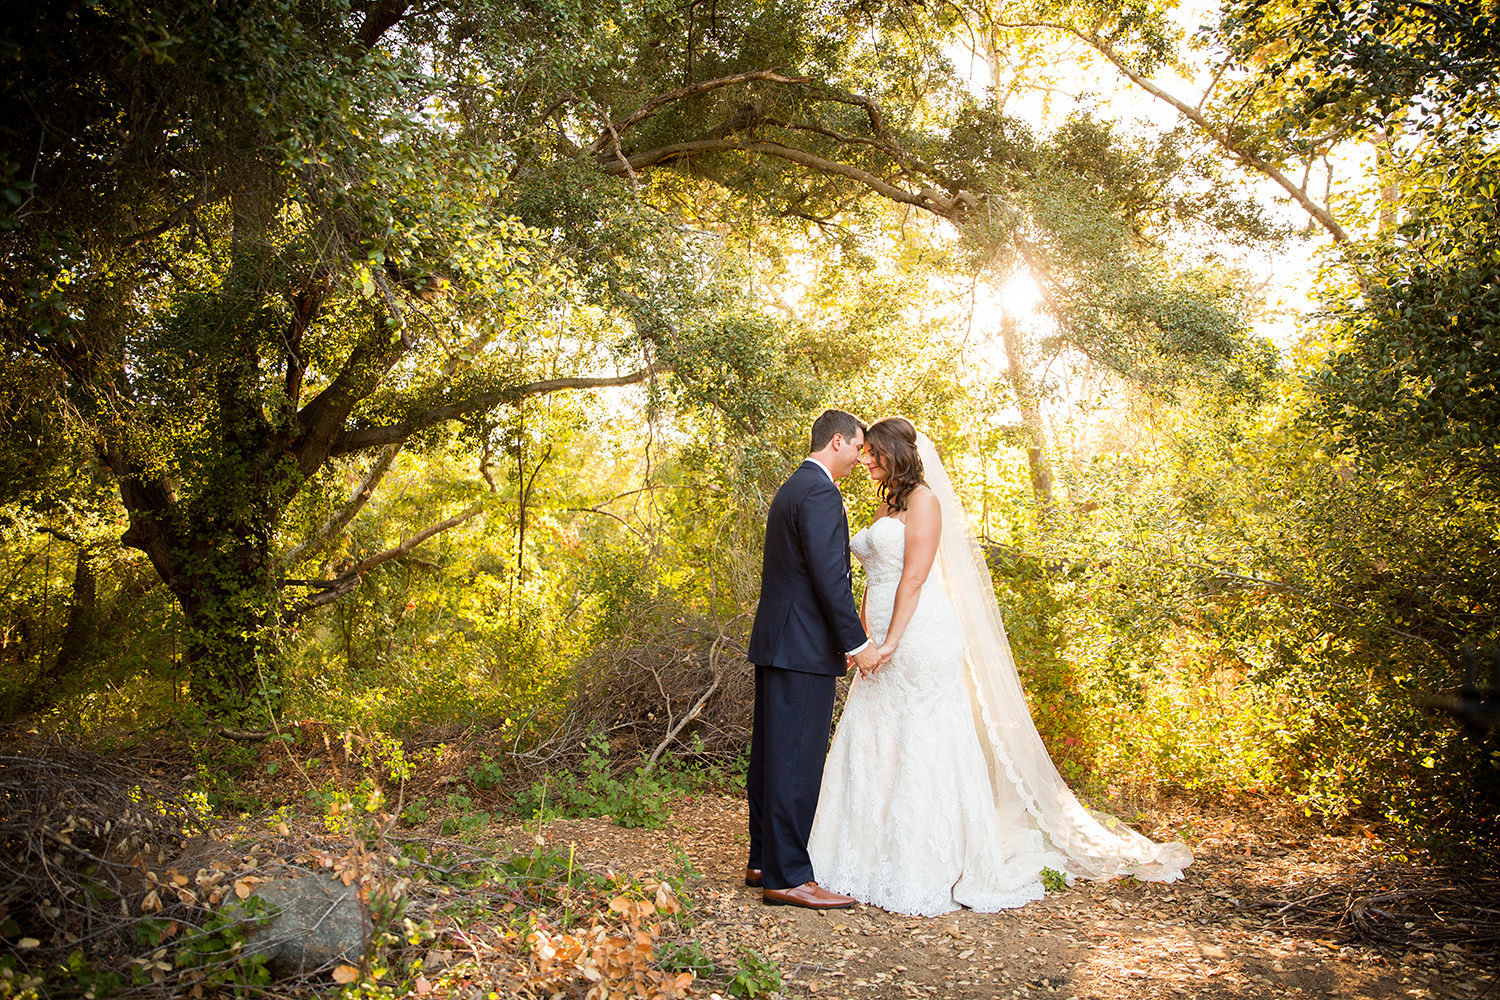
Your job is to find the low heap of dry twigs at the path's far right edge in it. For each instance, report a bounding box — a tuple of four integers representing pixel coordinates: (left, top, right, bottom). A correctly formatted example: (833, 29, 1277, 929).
(1248, 865, 1500, 957)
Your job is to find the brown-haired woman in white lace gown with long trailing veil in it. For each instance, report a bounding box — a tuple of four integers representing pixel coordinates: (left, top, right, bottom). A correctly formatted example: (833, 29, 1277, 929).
(807, 417, 1193, 916)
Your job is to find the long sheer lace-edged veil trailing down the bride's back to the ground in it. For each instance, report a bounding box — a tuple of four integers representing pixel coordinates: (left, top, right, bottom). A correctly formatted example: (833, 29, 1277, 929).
(917, 433, 1193, 882)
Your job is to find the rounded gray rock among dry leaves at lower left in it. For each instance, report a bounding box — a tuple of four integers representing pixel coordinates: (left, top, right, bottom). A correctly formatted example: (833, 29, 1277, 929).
(245, 876, 372, 979)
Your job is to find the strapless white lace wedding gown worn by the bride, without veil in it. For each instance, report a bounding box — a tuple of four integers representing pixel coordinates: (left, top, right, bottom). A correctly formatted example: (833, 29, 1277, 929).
(807, 517, 1064, 916)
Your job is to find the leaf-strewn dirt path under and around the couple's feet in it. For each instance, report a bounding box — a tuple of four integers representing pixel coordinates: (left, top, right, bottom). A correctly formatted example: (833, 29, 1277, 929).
(489, 796, 1500, 1000)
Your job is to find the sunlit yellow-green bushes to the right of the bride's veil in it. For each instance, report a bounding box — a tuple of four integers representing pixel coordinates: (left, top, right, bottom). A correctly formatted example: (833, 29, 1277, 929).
(986, 386, 1500, 843)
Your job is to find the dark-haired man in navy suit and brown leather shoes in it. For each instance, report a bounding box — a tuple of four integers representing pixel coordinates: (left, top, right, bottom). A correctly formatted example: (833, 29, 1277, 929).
(746, 409, 881, 910)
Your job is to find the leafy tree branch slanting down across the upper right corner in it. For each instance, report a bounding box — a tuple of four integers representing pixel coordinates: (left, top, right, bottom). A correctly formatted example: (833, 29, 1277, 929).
(968, 0, 1500, 243)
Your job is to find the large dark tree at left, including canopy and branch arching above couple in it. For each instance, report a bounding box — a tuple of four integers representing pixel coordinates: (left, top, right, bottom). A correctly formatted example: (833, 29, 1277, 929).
(0, 0, 1278, 711)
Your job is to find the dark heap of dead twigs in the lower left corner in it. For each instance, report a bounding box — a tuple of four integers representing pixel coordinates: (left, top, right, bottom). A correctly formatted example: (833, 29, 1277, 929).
(0, 733, 380, 996)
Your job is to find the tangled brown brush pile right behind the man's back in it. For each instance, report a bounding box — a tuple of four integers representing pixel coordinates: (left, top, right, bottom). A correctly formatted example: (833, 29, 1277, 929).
(521, 606, 755, 777)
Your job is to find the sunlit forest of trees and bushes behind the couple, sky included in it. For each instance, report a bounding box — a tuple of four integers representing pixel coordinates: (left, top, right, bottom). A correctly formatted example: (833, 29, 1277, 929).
(0, 0, 1500, 869)
